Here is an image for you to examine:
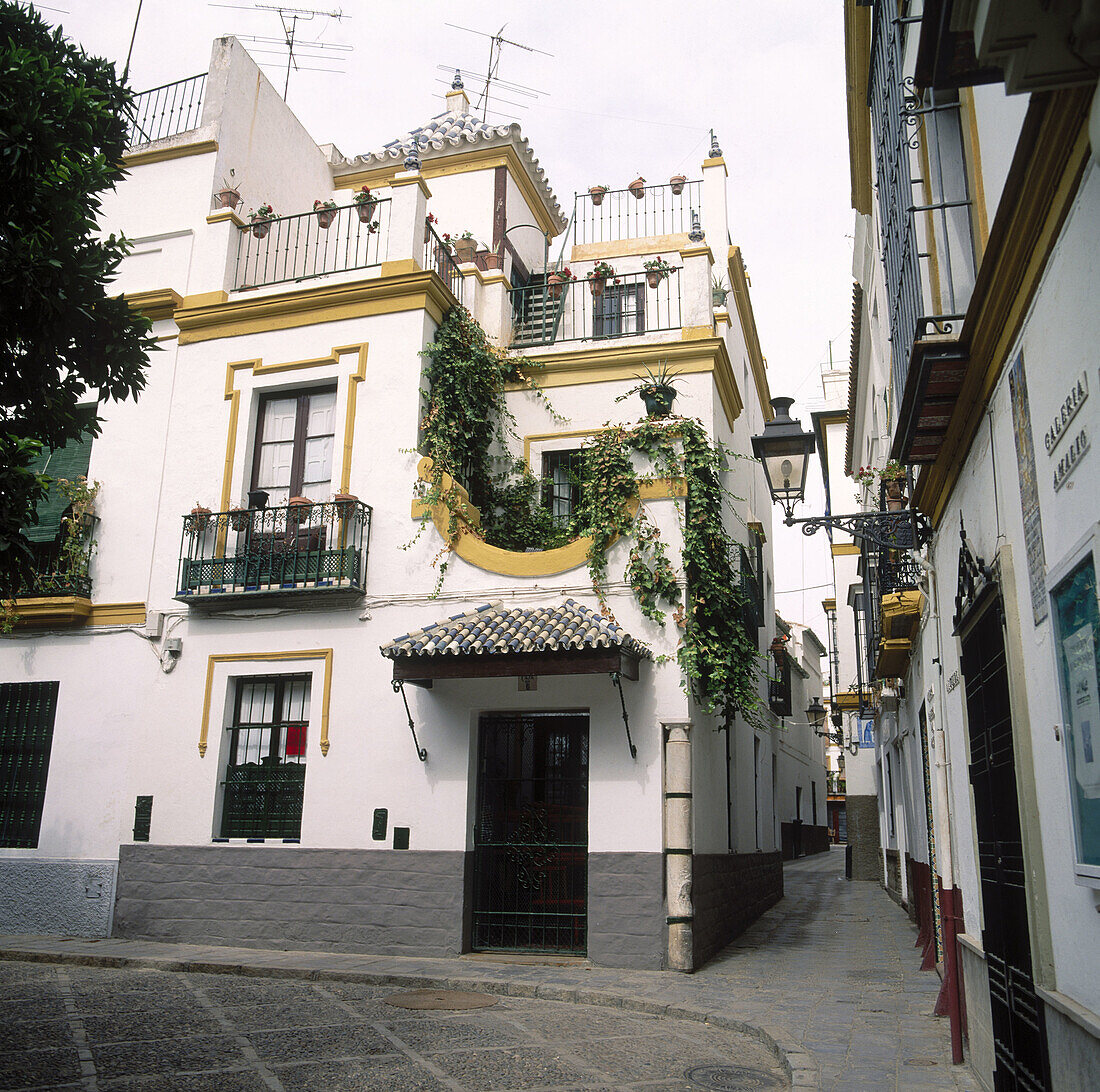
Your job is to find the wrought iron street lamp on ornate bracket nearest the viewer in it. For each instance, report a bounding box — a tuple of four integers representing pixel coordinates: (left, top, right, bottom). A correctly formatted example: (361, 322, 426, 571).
(752, 398, 932, 550)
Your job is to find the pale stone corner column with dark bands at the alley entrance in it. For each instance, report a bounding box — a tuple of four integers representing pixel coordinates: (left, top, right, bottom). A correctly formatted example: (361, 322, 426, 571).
(661, 720, 695, 973)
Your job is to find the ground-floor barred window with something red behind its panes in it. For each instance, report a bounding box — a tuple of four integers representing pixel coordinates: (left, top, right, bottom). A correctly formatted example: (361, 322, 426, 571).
(220, 674, 311, 839)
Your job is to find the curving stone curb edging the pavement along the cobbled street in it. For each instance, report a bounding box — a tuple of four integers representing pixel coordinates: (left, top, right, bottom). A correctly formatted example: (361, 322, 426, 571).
(0, 948, 821, 1089)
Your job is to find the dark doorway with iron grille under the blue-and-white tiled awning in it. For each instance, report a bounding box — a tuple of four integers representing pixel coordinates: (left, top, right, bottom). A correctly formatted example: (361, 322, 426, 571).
(472, 713, 589, 955)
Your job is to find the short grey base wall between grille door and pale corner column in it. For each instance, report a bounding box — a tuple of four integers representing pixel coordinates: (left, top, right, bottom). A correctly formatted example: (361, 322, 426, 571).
(589, 853, 668, 970)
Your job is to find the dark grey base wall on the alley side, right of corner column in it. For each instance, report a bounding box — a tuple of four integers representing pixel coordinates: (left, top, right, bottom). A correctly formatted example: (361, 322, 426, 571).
(692, 853, 783, 969)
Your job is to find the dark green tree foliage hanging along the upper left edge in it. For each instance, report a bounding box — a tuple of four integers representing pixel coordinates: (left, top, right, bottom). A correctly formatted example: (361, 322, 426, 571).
(0, 0, 153, 586)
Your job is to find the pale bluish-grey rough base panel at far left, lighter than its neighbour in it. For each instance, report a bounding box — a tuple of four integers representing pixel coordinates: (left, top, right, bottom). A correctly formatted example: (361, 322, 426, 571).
(0, 858, 118, 937)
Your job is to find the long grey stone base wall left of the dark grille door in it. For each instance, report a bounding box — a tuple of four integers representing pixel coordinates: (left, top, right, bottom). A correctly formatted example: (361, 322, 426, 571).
(114, 845, 466, 956)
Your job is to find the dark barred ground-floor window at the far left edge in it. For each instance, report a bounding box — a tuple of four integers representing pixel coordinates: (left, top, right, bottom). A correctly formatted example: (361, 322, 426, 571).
(0, 683, 61, 849)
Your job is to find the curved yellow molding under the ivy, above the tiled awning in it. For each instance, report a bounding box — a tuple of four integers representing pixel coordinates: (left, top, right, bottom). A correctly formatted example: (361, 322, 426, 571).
(411, 459, 688, 577)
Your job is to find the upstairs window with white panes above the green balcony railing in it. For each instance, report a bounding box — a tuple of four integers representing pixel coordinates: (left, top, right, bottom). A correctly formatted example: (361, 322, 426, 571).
(252, 388, 337, 507)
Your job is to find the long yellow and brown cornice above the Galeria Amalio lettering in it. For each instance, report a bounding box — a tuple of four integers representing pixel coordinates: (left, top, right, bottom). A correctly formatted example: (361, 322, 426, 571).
(914, 88, 1092, 528)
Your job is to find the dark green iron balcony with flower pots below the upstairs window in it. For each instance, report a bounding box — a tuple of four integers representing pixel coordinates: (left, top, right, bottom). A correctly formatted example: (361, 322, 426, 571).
(175, 499, 371, 610)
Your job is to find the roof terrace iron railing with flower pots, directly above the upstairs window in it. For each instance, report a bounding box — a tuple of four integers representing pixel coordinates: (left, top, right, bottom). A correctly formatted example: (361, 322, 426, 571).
(233, 197, 391, 290)
